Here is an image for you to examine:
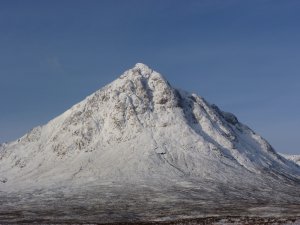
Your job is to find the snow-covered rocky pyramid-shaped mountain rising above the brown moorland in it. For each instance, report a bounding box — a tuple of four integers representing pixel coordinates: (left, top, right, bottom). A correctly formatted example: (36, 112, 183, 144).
(0, 63, 300, 191)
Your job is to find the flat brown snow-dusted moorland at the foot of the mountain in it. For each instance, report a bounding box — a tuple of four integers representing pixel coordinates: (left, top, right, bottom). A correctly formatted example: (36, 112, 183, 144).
(0, 185, 300, 225)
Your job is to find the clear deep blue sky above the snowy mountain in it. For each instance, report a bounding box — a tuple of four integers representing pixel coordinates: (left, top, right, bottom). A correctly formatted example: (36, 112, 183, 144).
(0, 0, 300, 153)
